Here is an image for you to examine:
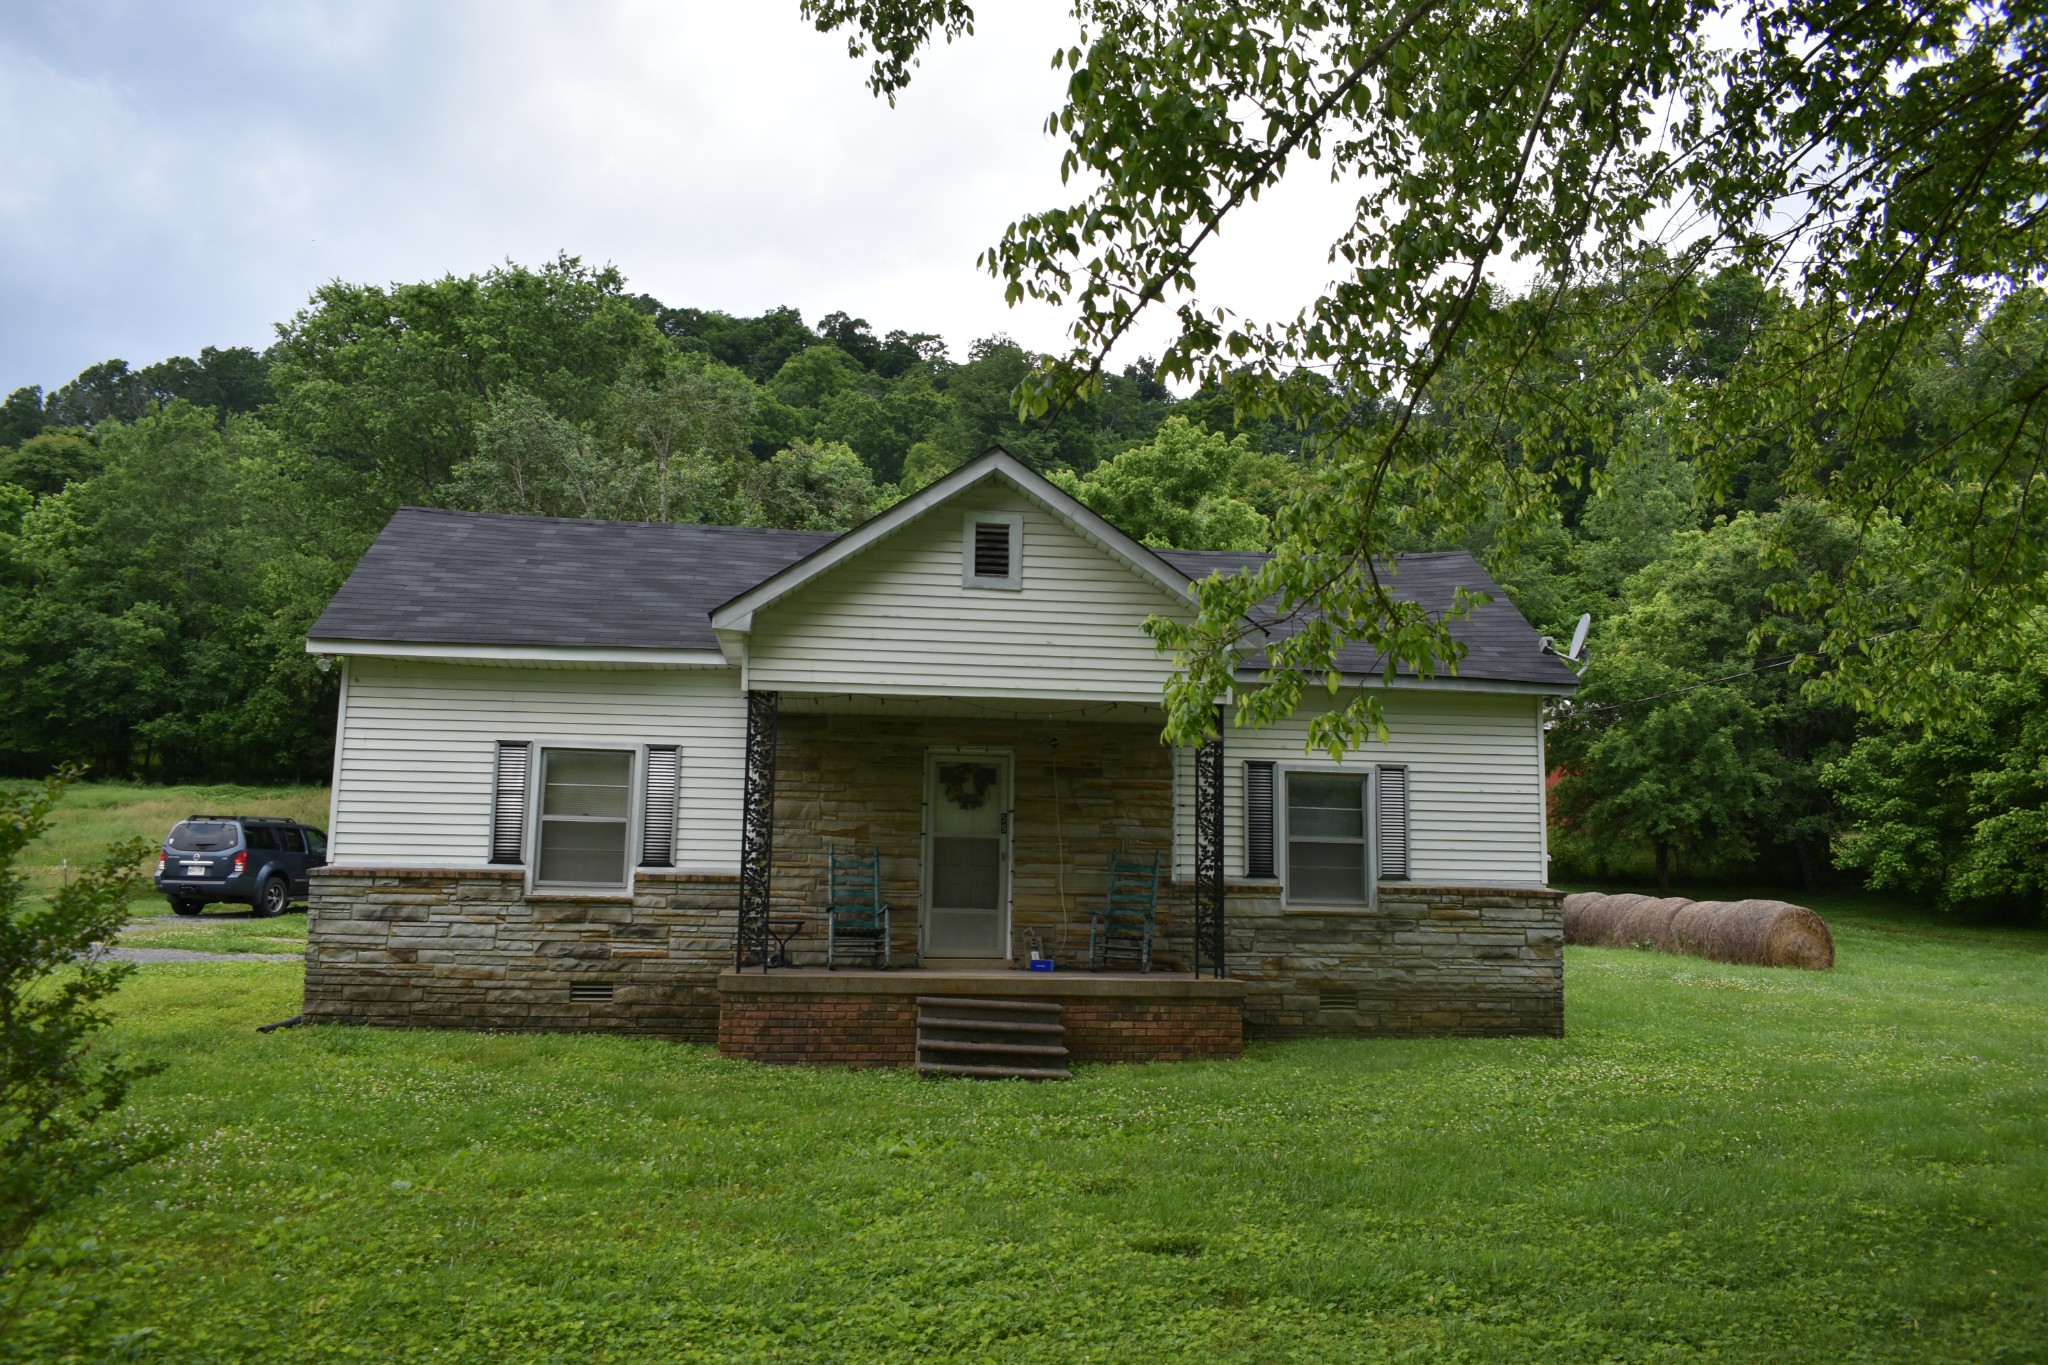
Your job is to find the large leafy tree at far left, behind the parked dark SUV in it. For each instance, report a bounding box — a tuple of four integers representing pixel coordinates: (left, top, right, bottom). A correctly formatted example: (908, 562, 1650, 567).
(0, 401, 335, 778)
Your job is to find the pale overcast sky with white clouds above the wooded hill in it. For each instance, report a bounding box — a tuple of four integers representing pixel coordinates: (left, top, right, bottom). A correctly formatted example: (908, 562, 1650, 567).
(0, 0, 1376, 393)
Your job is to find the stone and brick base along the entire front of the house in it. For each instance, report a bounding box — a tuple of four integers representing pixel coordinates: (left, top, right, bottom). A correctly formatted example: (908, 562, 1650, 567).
(305, 868, 1565, 1066)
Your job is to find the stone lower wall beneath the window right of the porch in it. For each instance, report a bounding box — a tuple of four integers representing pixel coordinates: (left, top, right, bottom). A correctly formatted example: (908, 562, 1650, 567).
(1225, 882, 1565, 1038)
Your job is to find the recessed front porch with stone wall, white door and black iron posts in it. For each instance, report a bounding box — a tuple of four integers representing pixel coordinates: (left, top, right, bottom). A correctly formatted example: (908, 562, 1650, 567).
(733, 692, 1225, 976)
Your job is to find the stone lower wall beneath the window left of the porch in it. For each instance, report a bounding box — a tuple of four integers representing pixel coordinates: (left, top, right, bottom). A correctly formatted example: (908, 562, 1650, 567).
(305, 868, 739, 1042)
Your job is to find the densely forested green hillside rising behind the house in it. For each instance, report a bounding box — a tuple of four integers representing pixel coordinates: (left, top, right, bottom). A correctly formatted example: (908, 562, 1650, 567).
(0, 258, 2048, 909)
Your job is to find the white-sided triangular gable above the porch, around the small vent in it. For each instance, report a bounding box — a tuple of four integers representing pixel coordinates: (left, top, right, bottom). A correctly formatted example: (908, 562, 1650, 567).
(748, 485, 1192, 704)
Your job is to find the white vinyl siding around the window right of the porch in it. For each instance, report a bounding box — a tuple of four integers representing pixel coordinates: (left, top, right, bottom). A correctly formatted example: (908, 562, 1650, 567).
(1174, 688, 1548, 886)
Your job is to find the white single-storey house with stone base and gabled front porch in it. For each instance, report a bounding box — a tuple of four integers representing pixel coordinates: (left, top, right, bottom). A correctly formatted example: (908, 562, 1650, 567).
(307, 450, 1575, 1062)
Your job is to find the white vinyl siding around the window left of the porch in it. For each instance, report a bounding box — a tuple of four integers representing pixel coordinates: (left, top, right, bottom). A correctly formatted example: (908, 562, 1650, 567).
(330, 659, 748, 872)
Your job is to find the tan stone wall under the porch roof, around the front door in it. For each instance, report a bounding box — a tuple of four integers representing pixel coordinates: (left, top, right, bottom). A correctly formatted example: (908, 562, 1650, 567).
(774, 712, 1192, 970)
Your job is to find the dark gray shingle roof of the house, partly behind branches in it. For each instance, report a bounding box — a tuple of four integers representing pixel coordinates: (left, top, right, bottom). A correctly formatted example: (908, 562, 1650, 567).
(311, 508, 1577, 688)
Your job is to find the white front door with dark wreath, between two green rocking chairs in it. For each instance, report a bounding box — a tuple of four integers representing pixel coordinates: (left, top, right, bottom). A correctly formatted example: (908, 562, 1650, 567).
(924, 749, 1010, 958)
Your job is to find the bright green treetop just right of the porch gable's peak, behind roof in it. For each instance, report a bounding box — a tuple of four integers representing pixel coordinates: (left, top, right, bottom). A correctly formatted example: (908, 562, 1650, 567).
(1053, 417, 1274, 551)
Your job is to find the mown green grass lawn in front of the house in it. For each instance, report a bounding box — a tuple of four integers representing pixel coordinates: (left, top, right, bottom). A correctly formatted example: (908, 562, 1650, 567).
(0, 898, 2048, 1363)
